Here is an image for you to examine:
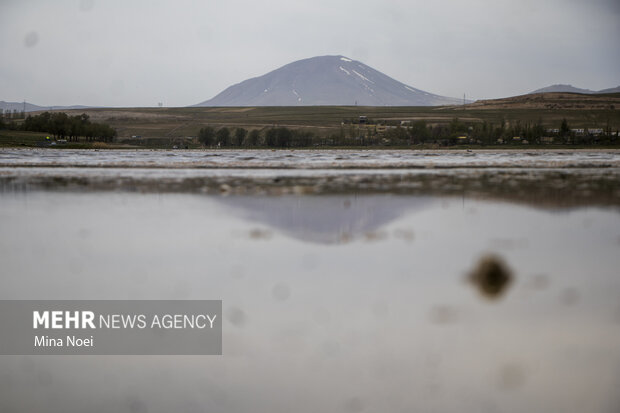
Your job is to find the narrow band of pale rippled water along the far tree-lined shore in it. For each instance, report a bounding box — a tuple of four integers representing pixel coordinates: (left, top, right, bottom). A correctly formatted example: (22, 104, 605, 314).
(0, 148, 620, 169)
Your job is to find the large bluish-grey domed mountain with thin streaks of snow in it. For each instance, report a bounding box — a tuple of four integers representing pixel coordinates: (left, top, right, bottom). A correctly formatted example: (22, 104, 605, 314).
(195, 56, 463, 106)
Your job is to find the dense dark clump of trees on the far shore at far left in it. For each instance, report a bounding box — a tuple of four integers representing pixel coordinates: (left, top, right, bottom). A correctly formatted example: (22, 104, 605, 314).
(20, 112, 116, 142)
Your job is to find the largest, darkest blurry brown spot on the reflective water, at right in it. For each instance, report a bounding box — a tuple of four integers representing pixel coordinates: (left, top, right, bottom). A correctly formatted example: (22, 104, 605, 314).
(468, 254, 512, 300)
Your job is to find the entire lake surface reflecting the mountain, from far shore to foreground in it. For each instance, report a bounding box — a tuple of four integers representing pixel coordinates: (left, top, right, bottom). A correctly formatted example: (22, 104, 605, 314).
(0, 150, 620, 413)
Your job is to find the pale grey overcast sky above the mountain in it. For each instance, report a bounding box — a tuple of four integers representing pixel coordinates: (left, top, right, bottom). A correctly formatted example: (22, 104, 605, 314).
(0, 0, 620, 106)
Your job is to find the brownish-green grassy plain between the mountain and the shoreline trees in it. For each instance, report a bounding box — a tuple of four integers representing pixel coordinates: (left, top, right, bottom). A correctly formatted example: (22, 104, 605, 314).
(0, 93, 620, 147)
